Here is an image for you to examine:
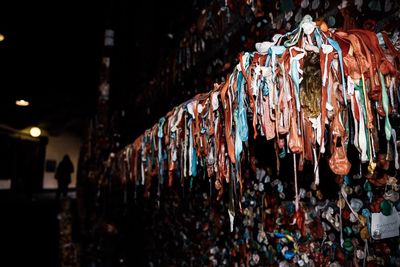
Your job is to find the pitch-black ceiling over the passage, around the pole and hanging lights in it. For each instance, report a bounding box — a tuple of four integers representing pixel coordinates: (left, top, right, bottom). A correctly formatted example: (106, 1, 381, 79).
(0, 0, 192, 134)
